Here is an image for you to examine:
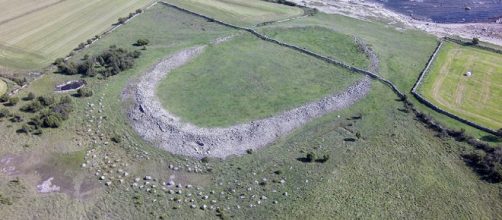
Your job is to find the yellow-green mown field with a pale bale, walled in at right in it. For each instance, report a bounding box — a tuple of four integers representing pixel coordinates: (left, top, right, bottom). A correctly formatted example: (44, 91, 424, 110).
(421, 42, 502, 130)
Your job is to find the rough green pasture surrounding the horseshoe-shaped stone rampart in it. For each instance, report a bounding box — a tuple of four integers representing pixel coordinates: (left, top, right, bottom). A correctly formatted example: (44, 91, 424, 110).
(0, 2, 502, 219)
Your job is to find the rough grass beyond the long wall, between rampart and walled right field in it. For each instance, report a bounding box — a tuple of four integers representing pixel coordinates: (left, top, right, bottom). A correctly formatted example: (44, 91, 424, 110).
(258, 13, 502, 143)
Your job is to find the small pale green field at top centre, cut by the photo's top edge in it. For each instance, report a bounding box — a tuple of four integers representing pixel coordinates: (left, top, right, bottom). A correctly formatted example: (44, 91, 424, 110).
(166, 0, 303, 25)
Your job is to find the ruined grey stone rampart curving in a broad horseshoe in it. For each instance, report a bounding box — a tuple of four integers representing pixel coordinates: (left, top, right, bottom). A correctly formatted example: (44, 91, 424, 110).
(123, 38, 378, 158)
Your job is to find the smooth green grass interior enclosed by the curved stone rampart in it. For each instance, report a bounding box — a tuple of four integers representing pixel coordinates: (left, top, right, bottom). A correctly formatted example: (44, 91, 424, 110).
(157, 31, 364, 127)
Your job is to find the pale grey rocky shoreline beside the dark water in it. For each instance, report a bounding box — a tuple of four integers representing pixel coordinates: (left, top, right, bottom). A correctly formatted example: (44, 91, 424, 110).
(291, 0, 502, 46)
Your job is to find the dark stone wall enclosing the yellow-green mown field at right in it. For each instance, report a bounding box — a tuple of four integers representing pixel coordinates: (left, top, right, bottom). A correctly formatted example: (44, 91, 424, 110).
(411, 38, 502, 135)
